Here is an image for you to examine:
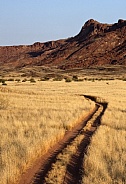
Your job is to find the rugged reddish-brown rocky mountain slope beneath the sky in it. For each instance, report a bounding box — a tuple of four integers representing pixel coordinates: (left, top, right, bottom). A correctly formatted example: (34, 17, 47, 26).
(0, 19, 126, 69)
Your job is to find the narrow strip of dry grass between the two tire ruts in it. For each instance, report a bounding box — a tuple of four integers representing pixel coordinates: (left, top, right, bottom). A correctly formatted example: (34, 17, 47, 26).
(44, 102, 103, 184)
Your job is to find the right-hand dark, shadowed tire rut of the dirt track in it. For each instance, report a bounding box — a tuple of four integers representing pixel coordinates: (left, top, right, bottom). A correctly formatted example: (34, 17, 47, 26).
(63, 96, 107, 184)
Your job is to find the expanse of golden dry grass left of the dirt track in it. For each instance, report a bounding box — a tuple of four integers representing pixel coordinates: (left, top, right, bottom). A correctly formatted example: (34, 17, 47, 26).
(0, 81, 94, 184)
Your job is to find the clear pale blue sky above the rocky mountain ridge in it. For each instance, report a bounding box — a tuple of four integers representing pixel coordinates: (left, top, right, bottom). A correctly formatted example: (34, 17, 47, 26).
(0, 0, 126, 46)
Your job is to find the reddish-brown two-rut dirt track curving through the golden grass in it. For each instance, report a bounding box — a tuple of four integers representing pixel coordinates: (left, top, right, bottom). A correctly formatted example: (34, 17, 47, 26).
(19, 95, 107, 184)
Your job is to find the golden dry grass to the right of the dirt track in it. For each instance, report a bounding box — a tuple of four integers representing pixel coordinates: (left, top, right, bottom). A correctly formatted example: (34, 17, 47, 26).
(83, 81, 126, 184)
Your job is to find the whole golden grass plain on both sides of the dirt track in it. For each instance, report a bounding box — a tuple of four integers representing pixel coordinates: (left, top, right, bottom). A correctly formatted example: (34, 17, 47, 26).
(0, 79, 126, 184)
